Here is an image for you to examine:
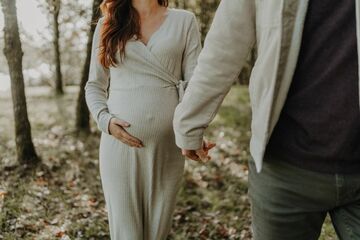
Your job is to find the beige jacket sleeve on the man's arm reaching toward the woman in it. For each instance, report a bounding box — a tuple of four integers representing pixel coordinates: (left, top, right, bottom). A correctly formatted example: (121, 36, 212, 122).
(173, 0, 256, 150)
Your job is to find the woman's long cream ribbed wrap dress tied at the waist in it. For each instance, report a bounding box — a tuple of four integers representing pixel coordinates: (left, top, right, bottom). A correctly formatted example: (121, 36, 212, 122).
(85, 9, 201, 240)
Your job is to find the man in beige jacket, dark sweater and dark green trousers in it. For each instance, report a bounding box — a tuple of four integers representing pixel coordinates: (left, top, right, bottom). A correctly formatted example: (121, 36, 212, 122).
(174, 0, 360, 240)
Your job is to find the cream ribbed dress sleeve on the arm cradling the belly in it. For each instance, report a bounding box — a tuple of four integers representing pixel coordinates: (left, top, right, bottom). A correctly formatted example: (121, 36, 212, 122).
(85, 19, 113, 134)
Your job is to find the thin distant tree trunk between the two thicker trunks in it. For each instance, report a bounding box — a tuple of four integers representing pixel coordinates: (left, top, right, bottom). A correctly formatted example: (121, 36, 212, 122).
(52, 0, 64, 95)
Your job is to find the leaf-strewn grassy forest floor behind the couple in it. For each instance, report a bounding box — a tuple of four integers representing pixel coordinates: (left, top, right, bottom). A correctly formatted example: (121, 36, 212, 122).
(0, 86, 337, 240)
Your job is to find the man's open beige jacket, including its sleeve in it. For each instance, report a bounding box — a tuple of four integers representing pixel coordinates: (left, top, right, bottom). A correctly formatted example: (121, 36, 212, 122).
(174, 0, 360, 172)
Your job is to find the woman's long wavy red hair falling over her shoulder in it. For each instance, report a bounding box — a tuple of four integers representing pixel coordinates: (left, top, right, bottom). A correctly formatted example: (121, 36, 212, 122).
(99, 0, 168, 68)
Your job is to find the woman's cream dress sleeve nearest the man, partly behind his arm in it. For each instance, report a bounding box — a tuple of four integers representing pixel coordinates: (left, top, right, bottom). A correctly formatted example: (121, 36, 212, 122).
(182, 14, 201, 82)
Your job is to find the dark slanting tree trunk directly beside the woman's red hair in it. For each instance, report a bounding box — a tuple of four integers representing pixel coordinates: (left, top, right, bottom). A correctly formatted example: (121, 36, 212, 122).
(75, 0, 102, 132)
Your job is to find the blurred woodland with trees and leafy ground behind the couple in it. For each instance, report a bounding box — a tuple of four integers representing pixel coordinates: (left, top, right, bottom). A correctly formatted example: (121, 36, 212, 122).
(0, 0, 336, 240)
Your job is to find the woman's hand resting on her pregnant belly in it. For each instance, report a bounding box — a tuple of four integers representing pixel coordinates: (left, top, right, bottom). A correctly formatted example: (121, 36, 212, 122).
(109, 117, 144, 148)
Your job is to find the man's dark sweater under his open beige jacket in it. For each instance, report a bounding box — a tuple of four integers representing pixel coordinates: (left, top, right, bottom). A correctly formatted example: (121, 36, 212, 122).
(265, 0, 360, 173)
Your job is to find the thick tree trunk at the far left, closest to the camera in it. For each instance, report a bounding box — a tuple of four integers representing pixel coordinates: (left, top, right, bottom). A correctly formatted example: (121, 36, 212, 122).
(0, 0, 40, 165)
